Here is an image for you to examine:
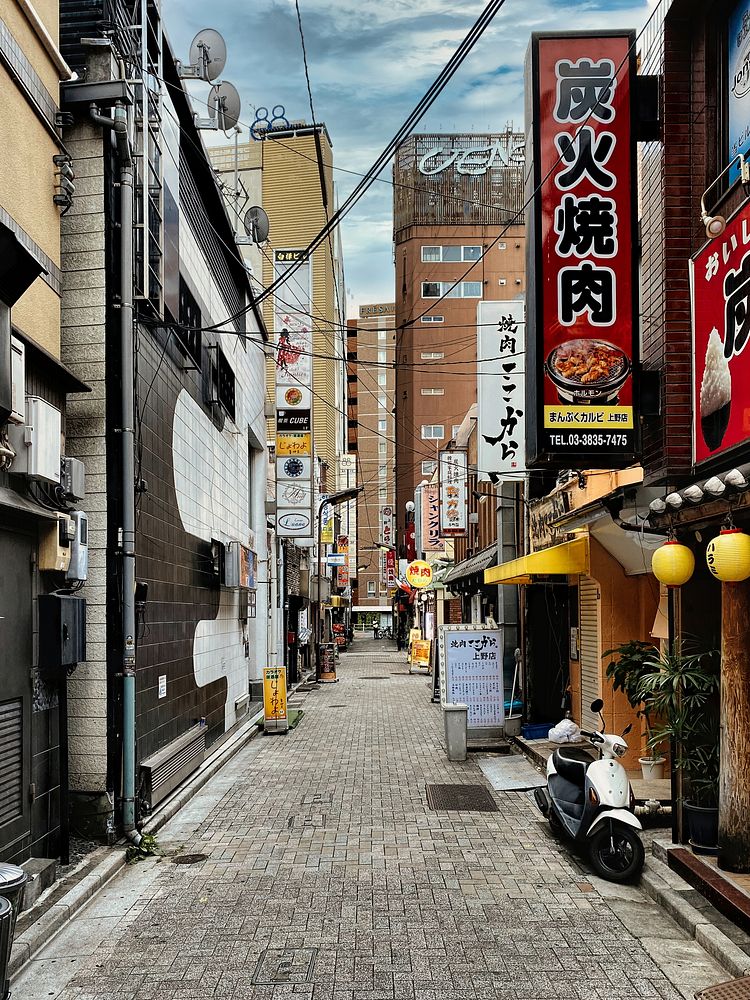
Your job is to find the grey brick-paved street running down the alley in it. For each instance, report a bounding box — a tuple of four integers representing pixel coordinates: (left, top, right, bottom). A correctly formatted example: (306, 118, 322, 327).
(14, 640, 727, 1000)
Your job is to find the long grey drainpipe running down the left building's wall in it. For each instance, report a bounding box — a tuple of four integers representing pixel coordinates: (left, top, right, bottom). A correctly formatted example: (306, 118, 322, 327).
(89, 102, 141, 844)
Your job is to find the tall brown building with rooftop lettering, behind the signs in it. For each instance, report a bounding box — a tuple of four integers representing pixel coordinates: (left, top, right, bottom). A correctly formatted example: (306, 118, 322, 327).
(394, 135, 525, 540)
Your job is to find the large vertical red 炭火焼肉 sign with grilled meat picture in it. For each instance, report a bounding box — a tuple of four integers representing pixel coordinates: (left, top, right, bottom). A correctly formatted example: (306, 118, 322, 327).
(526, 32, 638, 469)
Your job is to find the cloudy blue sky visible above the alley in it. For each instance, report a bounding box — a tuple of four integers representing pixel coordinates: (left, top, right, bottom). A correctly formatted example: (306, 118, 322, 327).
(163, 0, 658, 316)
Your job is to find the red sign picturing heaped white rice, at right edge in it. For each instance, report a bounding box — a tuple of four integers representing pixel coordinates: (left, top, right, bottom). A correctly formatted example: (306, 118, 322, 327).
(691, 206, 750, 465)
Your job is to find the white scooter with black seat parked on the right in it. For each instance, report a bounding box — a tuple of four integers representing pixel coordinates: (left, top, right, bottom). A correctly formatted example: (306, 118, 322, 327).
(534, 698, 644, 882)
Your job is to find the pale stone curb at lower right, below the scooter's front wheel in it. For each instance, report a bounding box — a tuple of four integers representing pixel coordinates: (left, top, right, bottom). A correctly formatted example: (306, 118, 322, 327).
(640, 856, 750, 979)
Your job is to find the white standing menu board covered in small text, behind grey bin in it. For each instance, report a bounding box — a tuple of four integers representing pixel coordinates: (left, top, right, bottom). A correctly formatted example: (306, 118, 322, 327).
(438, 625, 505, 730)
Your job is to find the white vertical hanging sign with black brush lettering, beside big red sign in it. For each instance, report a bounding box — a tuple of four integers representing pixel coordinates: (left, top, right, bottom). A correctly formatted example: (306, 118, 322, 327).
(477, 301, 526, 482)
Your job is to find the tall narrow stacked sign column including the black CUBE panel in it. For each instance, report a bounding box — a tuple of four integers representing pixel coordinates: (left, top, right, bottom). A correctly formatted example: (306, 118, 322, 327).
(274, 250, 314, 543)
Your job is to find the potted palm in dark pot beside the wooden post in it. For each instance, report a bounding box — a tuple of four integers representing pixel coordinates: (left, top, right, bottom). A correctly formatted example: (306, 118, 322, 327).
(638, 650, 720, 852)
